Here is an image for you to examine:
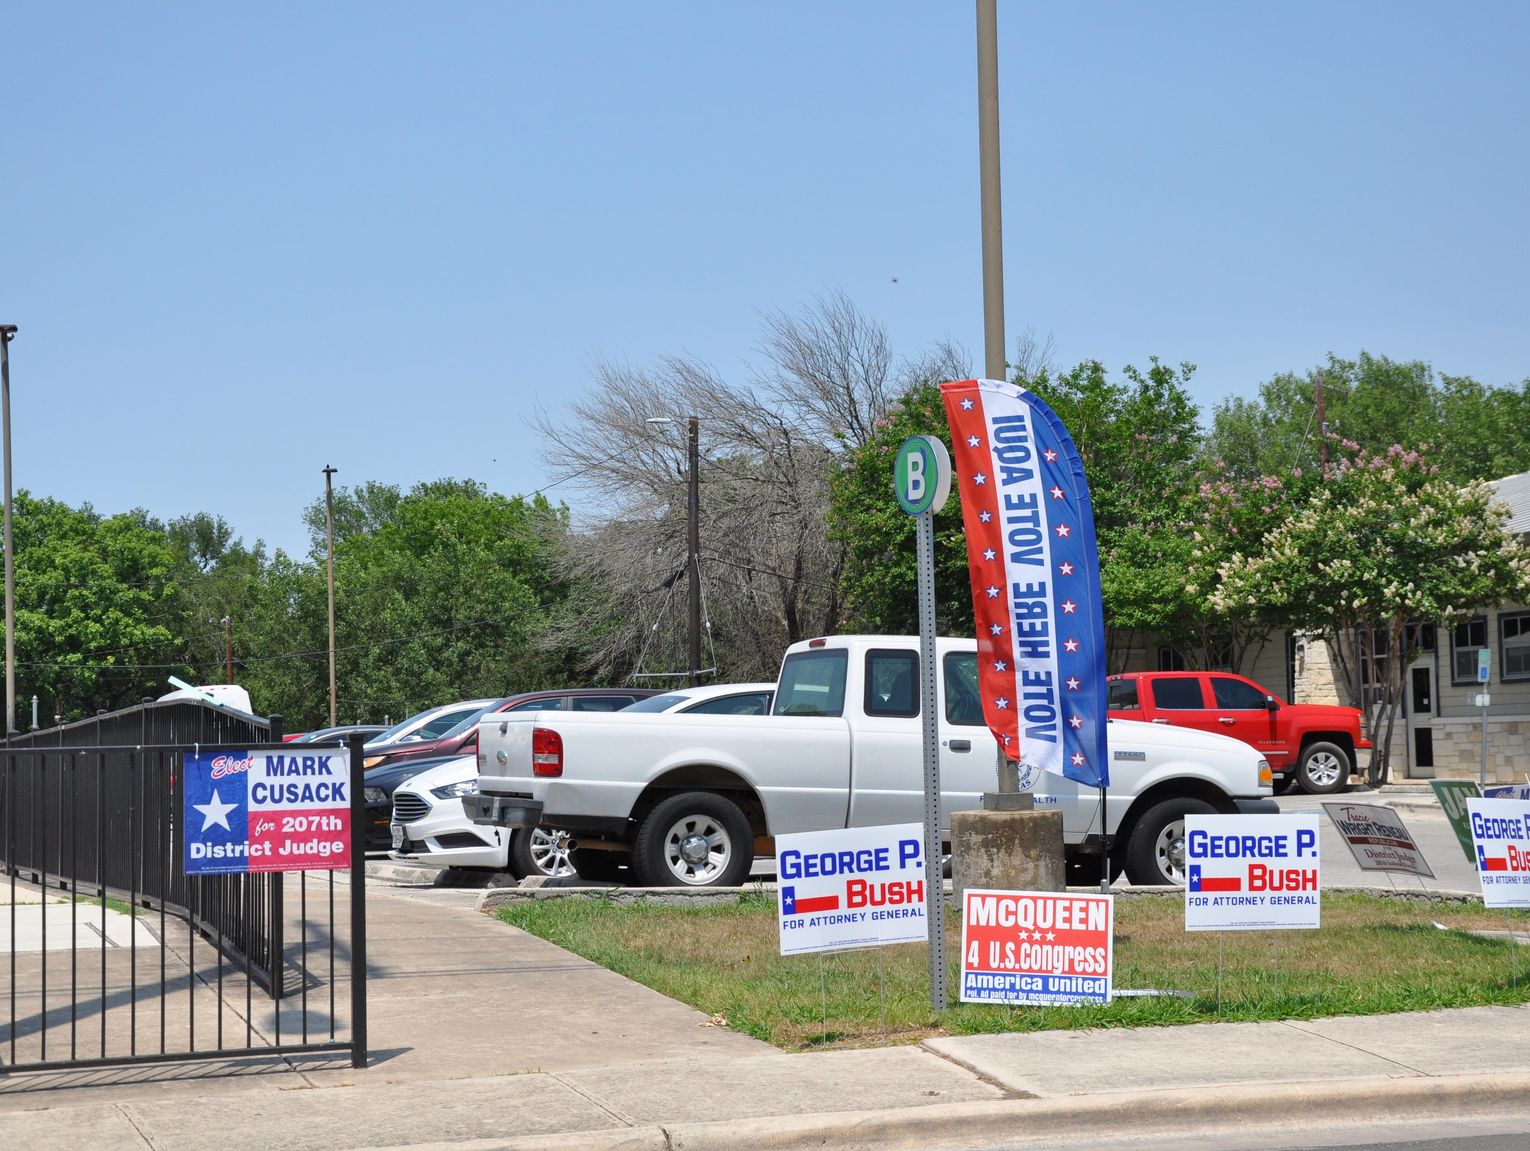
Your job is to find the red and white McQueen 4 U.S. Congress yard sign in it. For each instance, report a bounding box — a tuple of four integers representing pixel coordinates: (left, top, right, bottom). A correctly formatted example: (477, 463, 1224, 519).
(961, 888, 1115, 1007)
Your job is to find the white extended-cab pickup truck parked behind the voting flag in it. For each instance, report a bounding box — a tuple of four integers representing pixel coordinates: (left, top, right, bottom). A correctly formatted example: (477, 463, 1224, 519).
(464, 635, 1273, 886)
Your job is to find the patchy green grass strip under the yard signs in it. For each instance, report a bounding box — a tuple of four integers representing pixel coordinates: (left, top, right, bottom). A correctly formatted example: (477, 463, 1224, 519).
(499, 894, 1530, 1050)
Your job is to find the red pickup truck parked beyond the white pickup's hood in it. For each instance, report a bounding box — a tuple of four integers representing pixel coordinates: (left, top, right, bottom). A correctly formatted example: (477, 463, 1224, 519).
(1108, 672, 1371, 794)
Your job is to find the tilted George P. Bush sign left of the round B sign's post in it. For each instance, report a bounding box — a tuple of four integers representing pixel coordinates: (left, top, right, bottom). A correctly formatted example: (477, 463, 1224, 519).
(776, 823, 929, 955)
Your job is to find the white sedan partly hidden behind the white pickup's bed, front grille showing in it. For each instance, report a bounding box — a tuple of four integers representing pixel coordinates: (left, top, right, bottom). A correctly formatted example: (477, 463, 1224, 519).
(390, 684, 776, 877)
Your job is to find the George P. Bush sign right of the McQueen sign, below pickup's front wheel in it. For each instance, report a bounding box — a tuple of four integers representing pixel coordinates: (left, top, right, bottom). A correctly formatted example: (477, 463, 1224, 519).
(1184, 811, 1322, 931)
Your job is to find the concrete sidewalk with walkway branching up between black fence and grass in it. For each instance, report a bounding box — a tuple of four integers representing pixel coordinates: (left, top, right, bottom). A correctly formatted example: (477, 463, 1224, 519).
(0, 866, 1530, 1151)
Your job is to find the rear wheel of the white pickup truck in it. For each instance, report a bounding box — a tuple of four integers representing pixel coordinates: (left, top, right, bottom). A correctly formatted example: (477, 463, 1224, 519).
(632, 791, 754, 888)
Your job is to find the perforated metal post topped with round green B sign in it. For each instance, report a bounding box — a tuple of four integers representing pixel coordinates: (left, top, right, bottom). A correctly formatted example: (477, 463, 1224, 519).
(892, 436, 952, 1012)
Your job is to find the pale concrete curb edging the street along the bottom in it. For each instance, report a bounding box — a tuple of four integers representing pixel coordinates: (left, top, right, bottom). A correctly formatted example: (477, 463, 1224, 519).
(379, 1071, 1530, 1151)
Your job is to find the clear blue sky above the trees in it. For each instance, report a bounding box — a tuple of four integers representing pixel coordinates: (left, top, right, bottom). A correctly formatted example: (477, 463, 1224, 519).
(0, 0, 1530, 554)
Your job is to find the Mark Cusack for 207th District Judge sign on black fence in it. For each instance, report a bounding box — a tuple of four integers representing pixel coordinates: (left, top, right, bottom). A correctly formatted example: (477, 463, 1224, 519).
(182, 748, 352, 875)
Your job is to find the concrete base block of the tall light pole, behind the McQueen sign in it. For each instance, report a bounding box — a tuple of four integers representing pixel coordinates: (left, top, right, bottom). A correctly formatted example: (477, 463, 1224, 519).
(952, 811, 1068, 908)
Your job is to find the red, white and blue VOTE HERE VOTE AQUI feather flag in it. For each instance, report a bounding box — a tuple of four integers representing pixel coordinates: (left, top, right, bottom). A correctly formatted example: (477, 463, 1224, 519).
(941, 380, 1109, 787)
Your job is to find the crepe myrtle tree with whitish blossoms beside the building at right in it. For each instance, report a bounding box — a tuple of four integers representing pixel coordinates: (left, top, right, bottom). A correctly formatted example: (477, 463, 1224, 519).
(1210, 441, 1530, 784)
